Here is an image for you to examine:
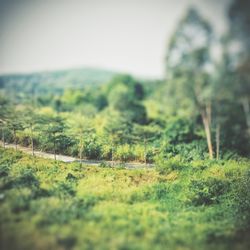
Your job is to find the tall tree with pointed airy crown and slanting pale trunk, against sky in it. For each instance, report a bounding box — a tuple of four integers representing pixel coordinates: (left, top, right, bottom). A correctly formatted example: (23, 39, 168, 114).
(166, 9, 214, 159)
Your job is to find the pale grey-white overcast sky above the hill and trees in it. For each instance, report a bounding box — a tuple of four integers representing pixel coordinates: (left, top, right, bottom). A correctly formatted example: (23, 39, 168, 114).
(0, 0, 230, 77)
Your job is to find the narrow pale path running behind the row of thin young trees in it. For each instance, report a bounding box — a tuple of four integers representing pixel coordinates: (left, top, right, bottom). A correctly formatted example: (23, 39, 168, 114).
(0, 141, 154, 169)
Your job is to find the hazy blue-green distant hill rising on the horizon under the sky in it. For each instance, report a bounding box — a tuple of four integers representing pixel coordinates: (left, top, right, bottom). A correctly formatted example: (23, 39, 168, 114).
(0, 68, 116, 93)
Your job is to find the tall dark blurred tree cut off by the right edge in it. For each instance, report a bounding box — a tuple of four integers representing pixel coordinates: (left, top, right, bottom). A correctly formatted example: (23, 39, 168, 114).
(210, 0, 250, 158)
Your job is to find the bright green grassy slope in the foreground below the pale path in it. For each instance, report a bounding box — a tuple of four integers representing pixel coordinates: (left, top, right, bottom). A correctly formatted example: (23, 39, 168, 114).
(0, 148, 250, 250)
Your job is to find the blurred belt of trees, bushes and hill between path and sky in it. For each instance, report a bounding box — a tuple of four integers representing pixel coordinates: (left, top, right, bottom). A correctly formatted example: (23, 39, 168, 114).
(0, 3, 250, 162)
